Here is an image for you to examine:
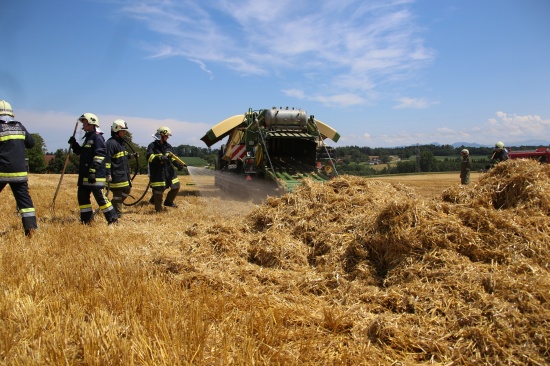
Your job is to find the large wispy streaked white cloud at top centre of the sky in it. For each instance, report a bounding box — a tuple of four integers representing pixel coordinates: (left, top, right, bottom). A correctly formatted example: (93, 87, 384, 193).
(121, 0, 434, 108)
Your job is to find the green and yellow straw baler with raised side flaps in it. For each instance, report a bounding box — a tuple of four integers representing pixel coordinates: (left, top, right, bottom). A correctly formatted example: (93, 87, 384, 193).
(201, 107, 340, 192)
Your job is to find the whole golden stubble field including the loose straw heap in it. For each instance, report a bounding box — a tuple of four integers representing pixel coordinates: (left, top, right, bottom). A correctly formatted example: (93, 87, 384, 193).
(0, 160, 550, 365)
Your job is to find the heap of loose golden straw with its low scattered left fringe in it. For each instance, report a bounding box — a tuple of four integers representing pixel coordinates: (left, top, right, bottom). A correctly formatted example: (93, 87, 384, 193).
(146, 161, 550, 365)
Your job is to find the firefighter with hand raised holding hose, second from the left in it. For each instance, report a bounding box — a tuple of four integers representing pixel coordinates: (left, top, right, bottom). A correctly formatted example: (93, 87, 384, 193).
(69, 113, 118, 225)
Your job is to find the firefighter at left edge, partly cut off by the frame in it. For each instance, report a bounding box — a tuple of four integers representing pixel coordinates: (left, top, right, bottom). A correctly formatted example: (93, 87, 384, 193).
(0, 100, 38, 237)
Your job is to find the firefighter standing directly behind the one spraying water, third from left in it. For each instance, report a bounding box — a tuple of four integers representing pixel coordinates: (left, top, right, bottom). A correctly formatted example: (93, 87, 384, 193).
(105, 119, 139, 218)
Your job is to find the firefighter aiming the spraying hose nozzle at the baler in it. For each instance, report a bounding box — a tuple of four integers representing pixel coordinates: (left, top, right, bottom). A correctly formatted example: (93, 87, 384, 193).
(147, 127, 184, 212)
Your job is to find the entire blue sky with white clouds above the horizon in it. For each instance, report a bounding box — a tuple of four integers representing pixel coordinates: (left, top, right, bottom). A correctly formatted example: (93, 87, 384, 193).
(0, 0, 550, 151)
